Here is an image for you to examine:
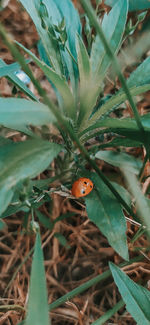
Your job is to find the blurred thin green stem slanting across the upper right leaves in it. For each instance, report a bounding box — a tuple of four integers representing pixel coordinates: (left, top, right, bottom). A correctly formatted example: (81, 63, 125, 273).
(80, 0, 144, 135)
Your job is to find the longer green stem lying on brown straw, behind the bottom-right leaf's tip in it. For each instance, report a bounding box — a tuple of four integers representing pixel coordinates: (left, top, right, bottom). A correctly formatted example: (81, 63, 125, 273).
(49, 256, 144, 311)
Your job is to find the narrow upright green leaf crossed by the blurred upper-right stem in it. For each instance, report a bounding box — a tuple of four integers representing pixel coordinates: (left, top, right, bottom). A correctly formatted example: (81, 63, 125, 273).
(79, 0, 128, 131)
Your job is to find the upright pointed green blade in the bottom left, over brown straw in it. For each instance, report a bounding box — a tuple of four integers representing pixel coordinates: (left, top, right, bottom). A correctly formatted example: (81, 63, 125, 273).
(25, 233, 50, 325)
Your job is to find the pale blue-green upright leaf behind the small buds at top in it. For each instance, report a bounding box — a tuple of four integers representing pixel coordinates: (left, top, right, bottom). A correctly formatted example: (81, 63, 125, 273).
(32, 0, 81, 90)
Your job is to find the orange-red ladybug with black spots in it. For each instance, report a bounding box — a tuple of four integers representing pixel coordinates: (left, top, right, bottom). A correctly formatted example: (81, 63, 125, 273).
(71, 177, 93, 197)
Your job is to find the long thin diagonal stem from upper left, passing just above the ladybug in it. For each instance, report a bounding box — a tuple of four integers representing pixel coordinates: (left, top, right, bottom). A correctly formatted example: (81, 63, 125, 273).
(0, 24, 135, 217)
